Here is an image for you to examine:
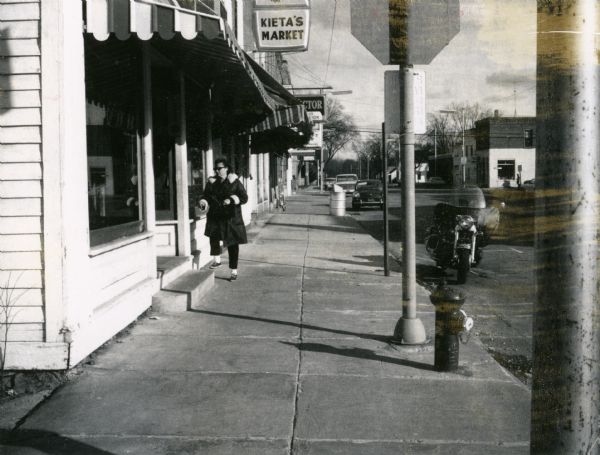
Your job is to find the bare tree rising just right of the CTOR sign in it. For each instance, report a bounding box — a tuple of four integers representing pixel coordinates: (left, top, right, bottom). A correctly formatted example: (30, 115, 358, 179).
(323, 98, 357, 170)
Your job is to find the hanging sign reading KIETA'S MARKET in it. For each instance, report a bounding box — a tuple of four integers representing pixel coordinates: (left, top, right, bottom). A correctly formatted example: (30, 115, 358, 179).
(254, 0, 310, 52)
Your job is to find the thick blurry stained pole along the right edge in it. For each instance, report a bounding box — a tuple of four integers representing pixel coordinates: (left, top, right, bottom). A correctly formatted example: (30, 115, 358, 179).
(531, 0, 600, 454)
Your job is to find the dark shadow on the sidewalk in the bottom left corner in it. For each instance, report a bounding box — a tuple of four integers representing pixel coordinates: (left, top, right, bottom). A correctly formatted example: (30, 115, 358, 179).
(0, 430, 113, 455)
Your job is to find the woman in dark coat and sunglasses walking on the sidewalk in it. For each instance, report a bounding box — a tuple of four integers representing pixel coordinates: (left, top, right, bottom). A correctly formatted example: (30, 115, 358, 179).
(200, 158, 248, 281)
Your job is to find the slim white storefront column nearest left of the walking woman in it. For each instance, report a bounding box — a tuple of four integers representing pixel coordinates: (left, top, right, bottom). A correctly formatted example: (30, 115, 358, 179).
(175, 70, 191, 256)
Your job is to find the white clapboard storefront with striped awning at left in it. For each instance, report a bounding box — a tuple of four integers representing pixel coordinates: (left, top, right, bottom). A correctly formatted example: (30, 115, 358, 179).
(0, 0, 310, 369)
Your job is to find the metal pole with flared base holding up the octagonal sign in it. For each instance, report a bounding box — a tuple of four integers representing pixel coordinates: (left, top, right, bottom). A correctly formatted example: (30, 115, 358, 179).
(393, 65, 426, 344)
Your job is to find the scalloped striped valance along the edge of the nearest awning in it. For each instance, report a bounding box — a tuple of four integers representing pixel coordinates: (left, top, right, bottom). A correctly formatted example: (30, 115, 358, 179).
(85, 0, 281, 112)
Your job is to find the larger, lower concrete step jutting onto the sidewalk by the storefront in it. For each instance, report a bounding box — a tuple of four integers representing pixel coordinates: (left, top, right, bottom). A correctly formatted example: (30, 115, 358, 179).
(152, 270, 215, 313)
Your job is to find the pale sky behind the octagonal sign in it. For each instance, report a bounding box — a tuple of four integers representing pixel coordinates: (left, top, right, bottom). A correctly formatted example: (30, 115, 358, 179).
(286, 0, 536, 131)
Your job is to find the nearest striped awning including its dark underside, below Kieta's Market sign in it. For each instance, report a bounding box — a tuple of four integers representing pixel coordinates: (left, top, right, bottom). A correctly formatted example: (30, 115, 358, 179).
(85, 0, 287, 130)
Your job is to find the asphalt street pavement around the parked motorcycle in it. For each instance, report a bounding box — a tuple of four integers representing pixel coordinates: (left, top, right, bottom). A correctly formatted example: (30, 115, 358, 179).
(346, 188, 535, 385)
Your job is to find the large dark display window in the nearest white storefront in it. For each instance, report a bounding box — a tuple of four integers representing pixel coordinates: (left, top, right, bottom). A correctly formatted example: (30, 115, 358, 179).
(85, 39, 146, 247)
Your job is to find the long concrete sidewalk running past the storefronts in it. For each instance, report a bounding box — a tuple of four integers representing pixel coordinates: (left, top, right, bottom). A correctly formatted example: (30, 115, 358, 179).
(0, 193, 530, 455)
